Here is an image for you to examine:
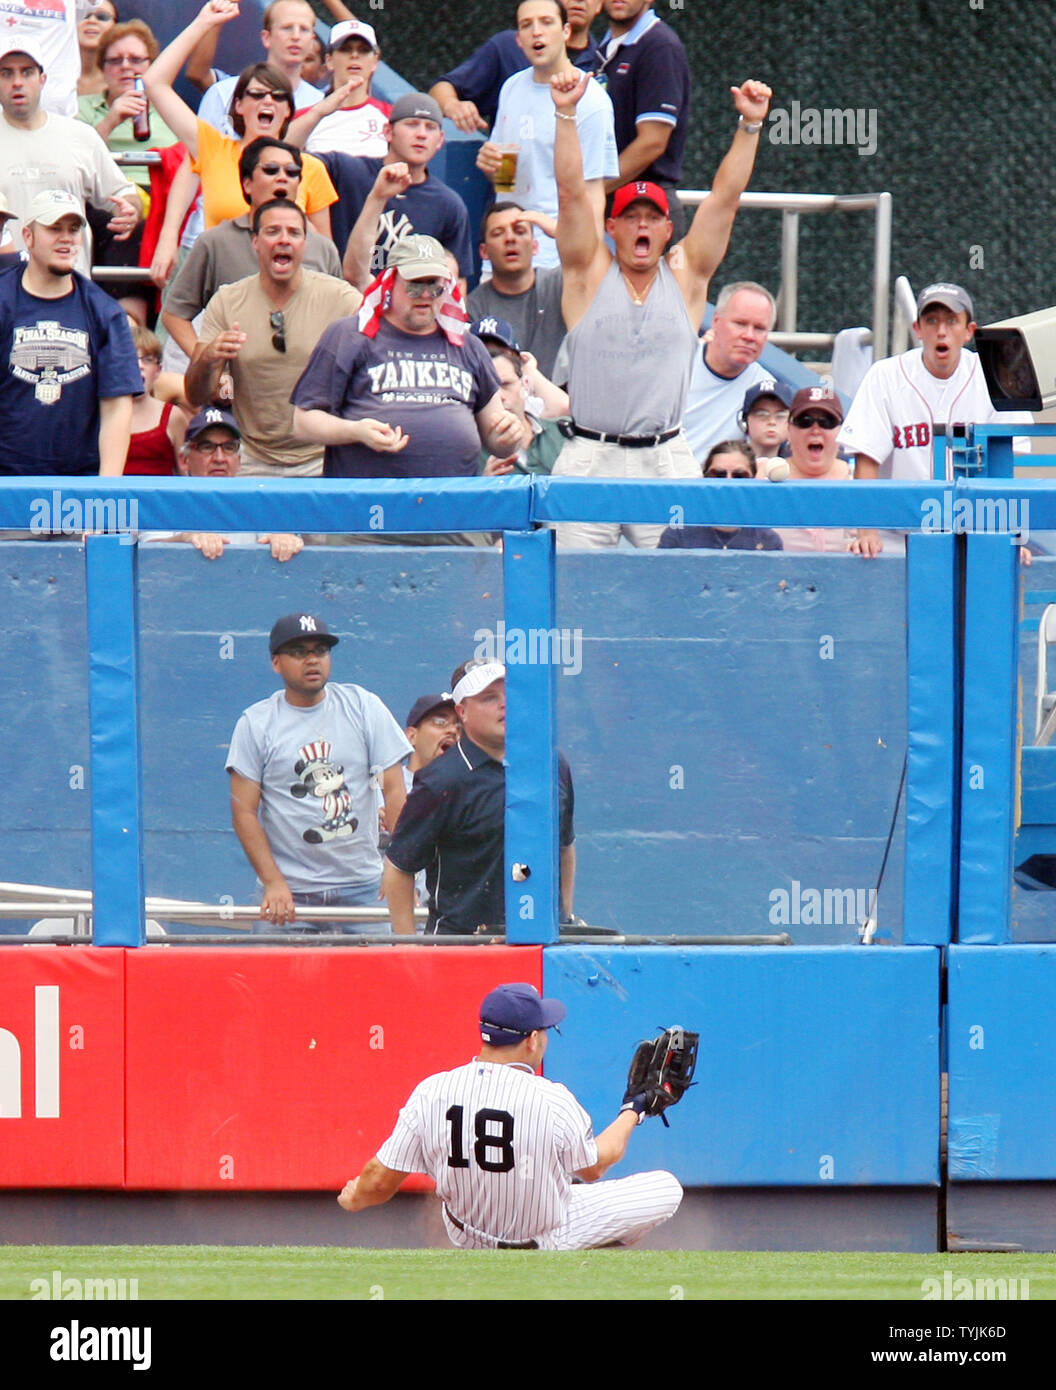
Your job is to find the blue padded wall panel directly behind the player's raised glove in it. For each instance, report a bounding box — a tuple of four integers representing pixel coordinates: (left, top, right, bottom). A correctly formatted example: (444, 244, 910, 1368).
(543, 947, 939, 1187)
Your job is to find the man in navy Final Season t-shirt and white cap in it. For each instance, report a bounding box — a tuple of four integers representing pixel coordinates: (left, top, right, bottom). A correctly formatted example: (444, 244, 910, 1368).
(0, 189, 143, 475)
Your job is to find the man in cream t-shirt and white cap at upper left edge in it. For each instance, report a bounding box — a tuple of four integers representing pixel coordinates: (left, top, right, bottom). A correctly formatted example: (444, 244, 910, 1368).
(0, 35, 142, 275)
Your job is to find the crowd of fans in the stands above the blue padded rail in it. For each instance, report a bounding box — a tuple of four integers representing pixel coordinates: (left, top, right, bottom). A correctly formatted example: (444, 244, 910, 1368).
(0, 0, 1028, 559)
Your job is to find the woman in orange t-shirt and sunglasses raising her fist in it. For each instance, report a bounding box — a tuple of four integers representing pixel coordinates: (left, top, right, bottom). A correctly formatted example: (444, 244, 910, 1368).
(143, 0, 338, 236)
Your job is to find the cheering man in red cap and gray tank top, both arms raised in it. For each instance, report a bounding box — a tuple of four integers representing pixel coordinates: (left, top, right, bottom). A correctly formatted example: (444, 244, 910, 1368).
(550, 71, 771, 549)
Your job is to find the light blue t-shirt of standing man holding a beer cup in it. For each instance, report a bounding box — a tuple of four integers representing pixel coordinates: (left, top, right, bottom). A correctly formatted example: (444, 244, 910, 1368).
(490, 68, 620, 265)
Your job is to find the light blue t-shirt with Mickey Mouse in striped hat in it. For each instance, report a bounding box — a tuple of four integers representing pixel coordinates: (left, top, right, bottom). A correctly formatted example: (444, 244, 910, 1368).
(226, 684, 413, 892)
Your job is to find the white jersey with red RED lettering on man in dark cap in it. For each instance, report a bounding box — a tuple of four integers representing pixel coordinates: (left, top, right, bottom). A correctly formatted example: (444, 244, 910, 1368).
(839, 348, 1034, 480)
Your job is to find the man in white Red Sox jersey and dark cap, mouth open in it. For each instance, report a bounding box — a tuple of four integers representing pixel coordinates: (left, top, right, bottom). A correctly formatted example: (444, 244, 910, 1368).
(839, 284, 1034, 555)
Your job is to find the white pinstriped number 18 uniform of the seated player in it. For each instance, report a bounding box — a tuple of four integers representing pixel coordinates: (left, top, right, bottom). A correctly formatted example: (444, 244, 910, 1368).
(378, 1059, 682, 1250)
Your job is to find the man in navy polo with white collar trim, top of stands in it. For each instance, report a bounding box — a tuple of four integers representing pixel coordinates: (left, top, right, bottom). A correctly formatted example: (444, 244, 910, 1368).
(595, 0, 689, 236)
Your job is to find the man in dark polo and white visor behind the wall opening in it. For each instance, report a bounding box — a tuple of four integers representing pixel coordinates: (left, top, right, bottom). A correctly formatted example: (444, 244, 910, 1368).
(382, 662, 575, 935)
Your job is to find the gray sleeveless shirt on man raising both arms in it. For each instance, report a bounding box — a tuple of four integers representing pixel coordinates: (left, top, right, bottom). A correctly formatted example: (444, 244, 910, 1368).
(567, 260, 698, 435)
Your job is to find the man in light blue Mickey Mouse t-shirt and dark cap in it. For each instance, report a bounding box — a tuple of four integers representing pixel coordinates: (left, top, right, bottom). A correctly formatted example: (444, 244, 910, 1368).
(226, 613, 413, 931)
